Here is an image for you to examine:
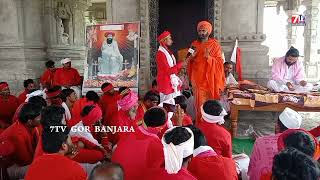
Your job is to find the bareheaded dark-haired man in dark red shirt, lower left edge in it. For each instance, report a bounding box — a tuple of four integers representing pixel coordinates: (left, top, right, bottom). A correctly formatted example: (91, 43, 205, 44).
(0, 103, 42, 179)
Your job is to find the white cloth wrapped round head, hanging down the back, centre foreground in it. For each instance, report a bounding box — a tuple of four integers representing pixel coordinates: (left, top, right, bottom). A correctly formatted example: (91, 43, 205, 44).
(161, 127, 194, 174)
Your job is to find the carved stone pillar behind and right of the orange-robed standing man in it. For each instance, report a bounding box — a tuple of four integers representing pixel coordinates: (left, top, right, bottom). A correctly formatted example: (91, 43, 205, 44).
(218, 0, 270, 85)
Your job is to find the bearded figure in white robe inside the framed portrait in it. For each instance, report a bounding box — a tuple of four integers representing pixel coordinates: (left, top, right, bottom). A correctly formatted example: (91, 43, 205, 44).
(98, 32, 123, 74)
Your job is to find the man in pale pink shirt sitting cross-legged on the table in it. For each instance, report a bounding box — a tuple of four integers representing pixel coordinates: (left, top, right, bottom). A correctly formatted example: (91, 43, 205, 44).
(268, 46, 313, 92)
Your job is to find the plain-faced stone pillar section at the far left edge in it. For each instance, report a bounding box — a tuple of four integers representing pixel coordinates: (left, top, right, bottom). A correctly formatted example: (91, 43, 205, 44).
(0, 0, 45, 94)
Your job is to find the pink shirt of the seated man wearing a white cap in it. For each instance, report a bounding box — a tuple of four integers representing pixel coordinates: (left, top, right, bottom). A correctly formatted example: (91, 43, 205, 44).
(248, 133, 281, 180)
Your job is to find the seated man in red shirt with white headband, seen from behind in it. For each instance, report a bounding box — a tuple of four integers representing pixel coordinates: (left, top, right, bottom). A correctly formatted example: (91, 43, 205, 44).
(198, 100, 232, 158)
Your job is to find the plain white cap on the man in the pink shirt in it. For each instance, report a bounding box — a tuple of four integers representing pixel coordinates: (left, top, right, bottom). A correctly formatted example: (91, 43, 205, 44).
(279, 107, 302, 129)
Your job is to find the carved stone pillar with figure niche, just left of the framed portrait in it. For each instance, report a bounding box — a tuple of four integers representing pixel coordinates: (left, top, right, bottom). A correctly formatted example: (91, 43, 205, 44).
(44, 0, 91, 73)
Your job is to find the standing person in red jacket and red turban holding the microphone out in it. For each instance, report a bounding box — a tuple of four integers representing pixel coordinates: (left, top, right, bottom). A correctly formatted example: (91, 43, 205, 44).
(156, 31, 183, 102)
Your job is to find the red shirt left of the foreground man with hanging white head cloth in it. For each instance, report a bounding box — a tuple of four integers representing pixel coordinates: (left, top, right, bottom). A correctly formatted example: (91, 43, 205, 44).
(111, 127, 164, 180)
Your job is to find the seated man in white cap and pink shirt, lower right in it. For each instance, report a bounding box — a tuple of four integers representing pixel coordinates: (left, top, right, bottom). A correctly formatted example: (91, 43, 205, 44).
(248, 107, 302, 180)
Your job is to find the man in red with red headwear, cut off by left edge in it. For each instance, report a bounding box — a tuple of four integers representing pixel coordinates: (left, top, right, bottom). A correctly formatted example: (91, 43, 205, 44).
(0, 82, 19, 133)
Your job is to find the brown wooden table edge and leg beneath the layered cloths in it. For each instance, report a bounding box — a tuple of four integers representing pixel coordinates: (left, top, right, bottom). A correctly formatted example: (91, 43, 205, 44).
(230, 103, 320, 137)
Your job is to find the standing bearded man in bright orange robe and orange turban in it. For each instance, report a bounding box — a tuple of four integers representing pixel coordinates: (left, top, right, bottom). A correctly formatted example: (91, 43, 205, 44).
(186, 21, 225, 123)
